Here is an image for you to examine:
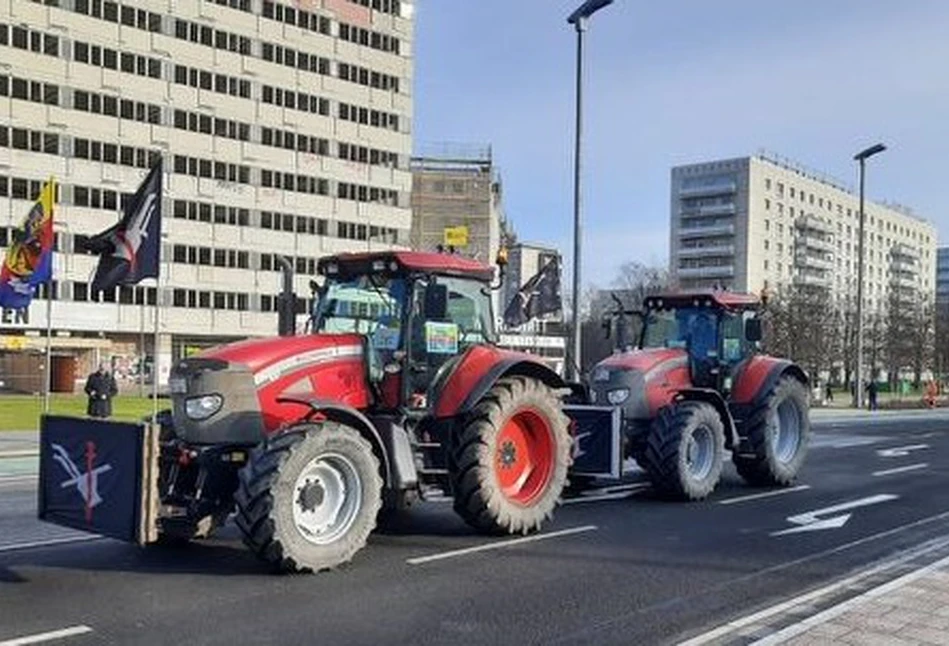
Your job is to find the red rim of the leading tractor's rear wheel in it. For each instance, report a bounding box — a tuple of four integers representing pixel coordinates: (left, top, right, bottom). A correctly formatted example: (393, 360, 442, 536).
(494, 410, 554, 505)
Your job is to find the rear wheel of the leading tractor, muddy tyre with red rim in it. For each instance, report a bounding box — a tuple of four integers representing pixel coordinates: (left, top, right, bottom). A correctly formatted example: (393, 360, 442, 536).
(449, 377, 573, 534)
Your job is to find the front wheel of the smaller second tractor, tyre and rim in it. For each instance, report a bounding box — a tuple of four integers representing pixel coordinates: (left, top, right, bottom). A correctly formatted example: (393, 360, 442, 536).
(643, 401, 725, 501)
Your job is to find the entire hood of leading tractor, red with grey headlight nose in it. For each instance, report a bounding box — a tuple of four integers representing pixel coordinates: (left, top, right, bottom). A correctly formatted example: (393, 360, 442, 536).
(169, 334, 369, 444)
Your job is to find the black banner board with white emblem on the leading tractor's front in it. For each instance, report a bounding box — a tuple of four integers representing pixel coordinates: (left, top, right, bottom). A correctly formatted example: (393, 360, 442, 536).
(37, 415, 152, 542)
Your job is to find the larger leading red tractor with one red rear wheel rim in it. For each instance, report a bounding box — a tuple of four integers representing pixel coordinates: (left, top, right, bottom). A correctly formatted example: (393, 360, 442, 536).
(41, 251, 572, 571)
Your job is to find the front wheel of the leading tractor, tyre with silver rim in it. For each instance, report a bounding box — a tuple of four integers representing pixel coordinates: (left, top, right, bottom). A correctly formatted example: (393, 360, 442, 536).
(234, 422, 383, 572)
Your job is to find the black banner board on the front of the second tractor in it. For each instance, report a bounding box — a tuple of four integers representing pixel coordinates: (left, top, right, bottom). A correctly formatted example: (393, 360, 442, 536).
(564, 406, 623, 478)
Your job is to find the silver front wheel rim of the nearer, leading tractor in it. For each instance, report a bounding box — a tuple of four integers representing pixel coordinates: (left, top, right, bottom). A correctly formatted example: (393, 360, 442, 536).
(293, 453, 362, 545)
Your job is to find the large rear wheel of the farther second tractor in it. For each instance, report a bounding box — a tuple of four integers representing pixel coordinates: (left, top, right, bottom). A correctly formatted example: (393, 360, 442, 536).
(732, 376, 811, 487)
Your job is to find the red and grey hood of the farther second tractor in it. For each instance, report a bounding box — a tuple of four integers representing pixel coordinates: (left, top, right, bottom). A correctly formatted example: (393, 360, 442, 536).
(590, 348, 689, 420)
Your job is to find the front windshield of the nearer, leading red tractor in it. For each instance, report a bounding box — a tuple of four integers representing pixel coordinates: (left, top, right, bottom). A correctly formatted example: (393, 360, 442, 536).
(315, 275, 408, 350)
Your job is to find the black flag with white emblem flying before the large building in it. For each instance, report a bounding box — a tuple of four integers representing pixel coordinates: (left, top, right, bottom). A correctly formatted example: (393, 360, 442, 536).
(85, 159, 162, 293)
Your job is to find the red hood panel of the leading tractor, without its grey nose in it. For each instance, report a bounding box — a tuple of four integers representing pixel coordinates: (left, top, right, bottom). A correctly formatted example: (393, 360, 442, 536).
(201, 334, 371, 433)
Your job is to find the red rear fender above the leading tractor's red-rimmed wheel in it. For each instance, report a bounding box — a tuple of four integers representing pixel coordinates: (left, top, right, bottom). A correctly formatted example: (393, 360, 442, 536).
(432, 345, 561, 418)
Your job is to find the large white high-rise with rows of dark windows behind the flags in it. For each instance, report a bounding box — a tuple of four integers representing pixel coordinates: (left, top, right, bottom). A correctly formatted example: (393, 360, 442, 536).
(0, 0, 413, 390)
